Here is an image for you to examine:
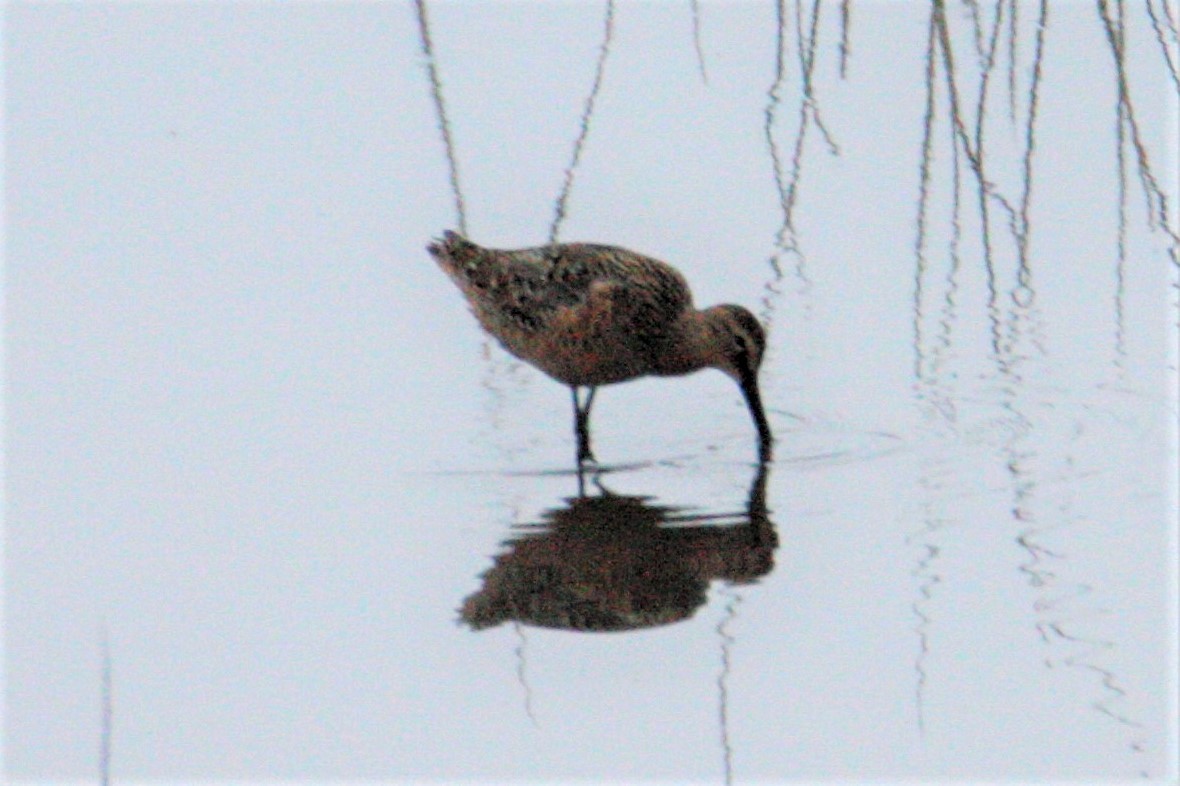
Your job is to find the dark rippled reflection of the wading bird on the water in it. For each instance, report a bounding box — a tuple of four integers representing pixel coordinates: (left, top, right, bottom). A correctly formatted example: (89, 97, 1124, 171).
(460, 463, 778, 631)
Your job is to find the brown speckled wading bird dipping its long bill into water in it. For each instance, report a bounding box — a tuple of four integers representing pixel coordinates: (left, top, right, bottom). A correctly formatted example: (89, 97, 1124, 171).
(426, 231, 773, 463)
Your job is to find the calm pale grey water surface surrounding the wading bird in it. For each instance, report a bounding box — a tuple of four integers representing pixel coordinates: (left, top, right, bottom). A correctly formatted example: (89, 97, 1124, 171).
(4, 2, 1178, 782)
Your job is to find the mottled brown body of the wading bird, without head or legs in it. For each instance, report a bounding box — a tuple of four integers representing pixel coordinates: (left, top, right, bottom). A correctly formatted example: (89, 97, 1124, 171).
(428, 227, 693, 385)
